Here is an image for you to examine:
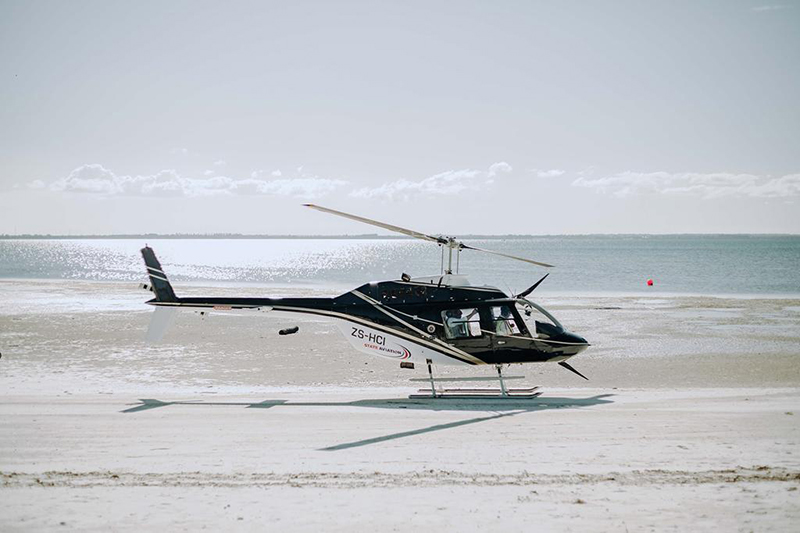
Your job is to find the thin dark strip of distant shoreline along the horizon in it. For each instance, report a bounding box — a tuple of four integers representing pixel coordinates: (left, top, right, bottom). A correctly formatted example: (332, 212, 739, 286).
(0, 233, 800, 241)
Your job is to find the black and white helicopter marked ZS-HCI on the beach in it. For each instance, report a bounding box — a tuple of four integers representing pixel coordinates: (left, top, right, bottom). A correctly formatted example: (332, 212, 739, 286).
(141, 204, 589, 398)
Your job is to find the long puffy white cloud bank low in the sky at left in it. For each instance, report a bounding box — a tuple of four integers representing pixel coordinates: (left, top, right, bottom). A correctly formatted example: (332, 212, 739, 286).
(43, 164, 347, 198)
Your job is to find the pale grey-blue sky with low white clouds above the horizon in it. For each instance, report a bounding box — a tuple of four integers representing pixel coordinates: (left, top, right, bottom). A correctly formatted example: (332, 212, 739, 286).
(0, 0, 800, 235)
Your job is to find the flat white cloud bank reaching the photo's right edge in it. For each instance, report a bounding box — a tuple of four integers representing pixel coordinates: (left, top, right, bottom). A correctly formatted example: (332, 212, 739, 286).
(572, 172, 800, 198)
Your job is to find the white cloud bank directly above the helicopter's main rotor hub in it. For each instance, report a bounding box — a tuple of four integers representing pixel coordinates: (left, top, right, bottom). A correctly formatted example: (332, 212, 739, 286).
(350, 162, 513, 200)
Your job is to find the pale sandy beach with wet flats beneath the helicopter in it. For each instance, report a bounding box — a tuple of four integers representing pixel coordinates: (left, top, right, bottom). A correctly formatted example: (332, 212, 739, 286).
(0, 280, 800, 531)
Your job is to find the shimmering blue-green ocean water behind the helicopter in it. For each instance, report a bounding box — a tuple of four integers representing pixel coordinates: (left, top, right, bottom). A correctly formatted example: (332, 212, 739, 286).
(0, 235, 800, 296)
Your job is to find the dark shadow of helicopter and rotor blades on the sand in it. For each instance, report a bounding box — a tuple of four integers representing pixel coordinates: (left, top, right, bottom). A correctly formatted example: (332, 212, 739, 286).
(122, 394, 614, 452)
